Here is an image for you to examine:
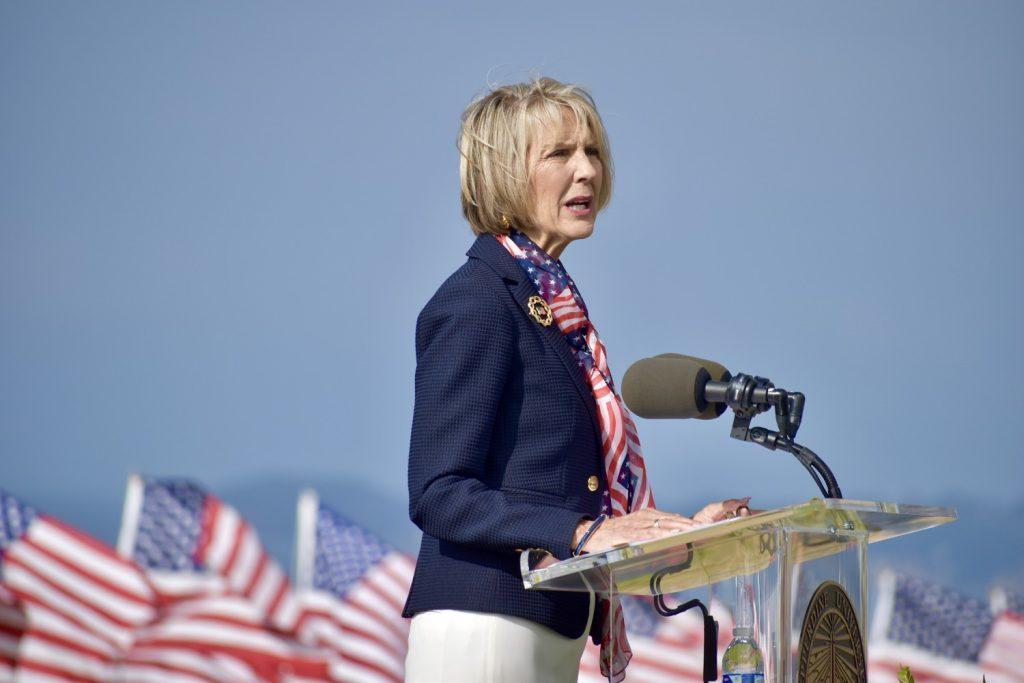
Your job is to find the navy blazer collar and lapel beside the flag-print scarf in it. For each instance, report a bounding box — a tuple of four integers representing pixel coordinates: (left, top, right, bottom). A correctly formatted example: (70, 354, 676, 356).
(466, 234, 601, 443)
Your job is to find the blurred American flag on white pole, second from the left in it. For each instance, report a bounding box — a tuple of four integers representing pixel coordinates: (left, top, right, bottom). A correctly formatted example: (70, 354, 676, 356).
(116, 475, 339, 681)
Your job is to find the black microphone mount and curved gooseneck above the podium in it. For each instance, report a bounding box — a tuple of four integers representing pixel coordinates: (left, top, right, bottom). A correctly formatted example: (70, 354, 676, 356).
(705, 374, 843, 498)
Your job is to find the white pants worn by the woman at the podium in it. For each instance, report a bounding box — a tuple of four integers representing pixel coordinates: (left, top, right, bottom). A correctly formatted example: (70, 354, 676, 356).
(406, 593, 594, 683)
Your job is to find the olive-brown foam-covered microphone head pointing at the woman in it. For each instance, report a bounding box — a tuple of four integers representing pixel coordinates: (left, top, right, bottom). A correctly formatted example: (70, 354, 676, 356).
(623, 353, 732, 420)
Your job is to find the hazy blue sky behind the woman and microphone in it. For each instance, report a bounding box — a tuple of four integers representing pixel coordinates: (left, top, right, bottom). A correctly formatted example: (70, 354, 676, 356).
(0, 1, 1024, 593)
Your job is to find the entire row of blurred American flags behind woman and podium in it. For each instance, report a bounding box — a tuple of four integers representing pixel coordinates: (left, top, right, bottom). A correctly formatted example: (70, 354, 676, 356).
(0, 476, 1024, 683)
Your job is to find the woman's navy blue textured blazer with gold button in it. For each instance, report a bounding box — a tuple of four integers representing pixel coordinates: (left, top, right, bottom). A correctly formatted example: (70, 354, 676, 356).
(403, 234, 606, 638)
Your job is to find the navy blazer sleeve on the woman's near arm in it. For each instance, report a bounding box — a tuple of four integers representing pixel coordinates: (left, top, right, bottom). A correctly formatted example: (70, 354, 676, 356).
(409, 283, 584, 558)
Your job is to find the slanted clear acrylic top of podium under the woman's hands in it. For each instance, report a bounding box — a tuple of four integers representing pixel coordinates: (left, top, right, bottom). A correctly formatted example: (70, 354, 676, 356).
(520, 498, 956, 595)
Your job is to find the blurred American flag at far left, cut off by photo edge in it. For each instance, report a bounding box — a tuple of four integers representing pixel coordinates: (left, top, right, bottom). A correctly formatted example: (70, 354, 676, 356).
(0, 492, 158, 682)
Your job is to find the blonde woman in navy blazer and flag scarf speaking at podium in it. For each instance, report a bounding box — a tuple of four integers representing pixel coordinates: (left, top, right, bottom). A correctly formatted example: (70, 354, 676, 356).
(404, 78, 746, 683)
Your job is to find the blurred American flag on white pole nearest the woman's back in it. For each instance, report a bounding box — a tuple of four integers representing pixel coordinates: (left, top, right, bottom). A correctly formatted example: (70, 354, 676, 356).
(296, 490, 415, 683)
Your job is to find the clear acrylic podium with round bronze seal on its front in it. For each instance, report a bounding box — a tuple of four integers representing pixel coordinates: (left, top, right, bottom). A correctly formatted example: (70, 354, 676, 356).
(520, 499, 956, 683)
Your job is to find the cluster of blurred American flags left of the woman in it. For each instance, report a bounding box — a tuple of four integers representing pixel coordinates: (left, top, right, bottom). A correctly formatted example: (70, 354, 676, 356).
(0, 476, 413, 683)
